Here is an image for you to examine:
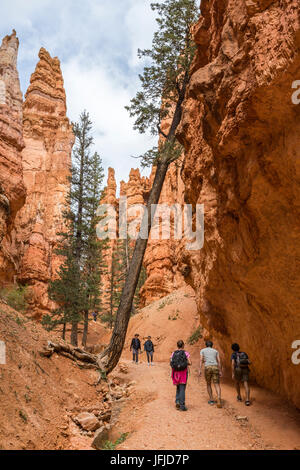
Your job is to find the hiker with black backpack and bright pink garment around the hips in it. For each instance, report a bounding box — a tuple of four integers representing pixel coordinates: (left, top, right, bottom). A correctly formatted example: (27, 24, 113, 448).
(170, 340, 192, 411)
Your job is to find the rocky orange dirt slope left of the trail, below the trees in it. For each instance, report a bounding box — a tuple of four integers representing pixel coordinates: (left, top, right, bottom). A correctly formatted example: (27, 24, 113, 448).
(0, 298, 134, 450)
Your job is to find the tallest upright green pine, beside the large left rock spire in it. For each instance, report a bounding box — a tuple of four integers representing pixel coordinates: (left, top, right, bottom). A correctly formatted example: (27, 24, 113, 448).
(43, 111, 103, 346)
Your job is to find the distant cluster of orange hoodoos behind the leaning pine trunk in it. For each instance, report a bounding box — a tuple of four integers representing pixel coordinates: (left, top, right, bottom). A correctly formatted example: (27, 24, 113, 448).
(101, 161, 185, 307)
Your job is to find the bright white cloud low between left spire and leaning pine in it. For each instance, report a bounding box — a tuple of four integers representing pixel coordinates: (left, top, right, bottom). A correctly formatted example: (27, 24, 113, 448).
(63, 59, 154, 185)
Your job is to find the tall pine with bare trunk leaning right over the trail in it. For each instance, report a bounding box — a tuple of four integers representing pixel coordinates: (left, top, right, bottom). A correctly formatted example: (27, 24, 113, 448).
(98, 0, 199, 373)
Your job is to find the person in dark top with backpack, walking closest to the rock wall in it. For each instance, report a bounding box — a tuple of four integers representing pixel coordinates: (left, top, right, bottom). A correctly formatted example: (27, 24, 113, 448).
(231, 343, 251, 406)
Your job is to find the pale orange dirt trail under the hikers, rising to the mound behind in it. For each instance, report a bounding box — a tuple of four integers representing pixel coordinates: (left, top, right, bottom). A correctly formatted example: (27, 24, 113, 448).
(102, 289, 300, 450)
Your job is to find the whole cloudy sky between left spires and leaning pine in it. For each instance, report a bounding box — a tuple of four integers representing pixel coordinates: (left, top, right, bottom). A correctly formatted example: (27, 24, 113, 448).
(0, 0, 164, 187)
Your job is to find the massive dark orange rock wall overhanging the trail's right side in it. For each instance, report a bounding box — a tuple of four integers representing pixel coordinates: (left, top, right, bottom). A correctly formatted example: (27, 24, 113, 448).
(178, 0, 300, 407)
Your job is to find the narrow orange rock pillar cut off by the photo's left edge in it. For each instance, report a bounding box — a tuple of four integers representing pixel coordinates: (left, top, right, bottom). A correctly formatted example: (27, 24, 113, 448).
(0, 31, 26, 283)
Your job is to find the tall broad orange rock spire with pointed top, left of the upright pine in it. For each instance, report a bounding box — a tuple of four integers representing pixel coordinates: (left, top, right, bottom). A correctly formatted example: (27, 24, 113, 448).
(17, 48, 74, 317)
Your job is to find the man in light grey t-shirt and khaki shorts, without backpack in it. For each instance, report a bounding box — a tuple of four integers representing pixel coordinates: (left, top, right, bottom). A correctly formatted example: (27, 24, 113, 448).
(199, 341, 222, 408)
